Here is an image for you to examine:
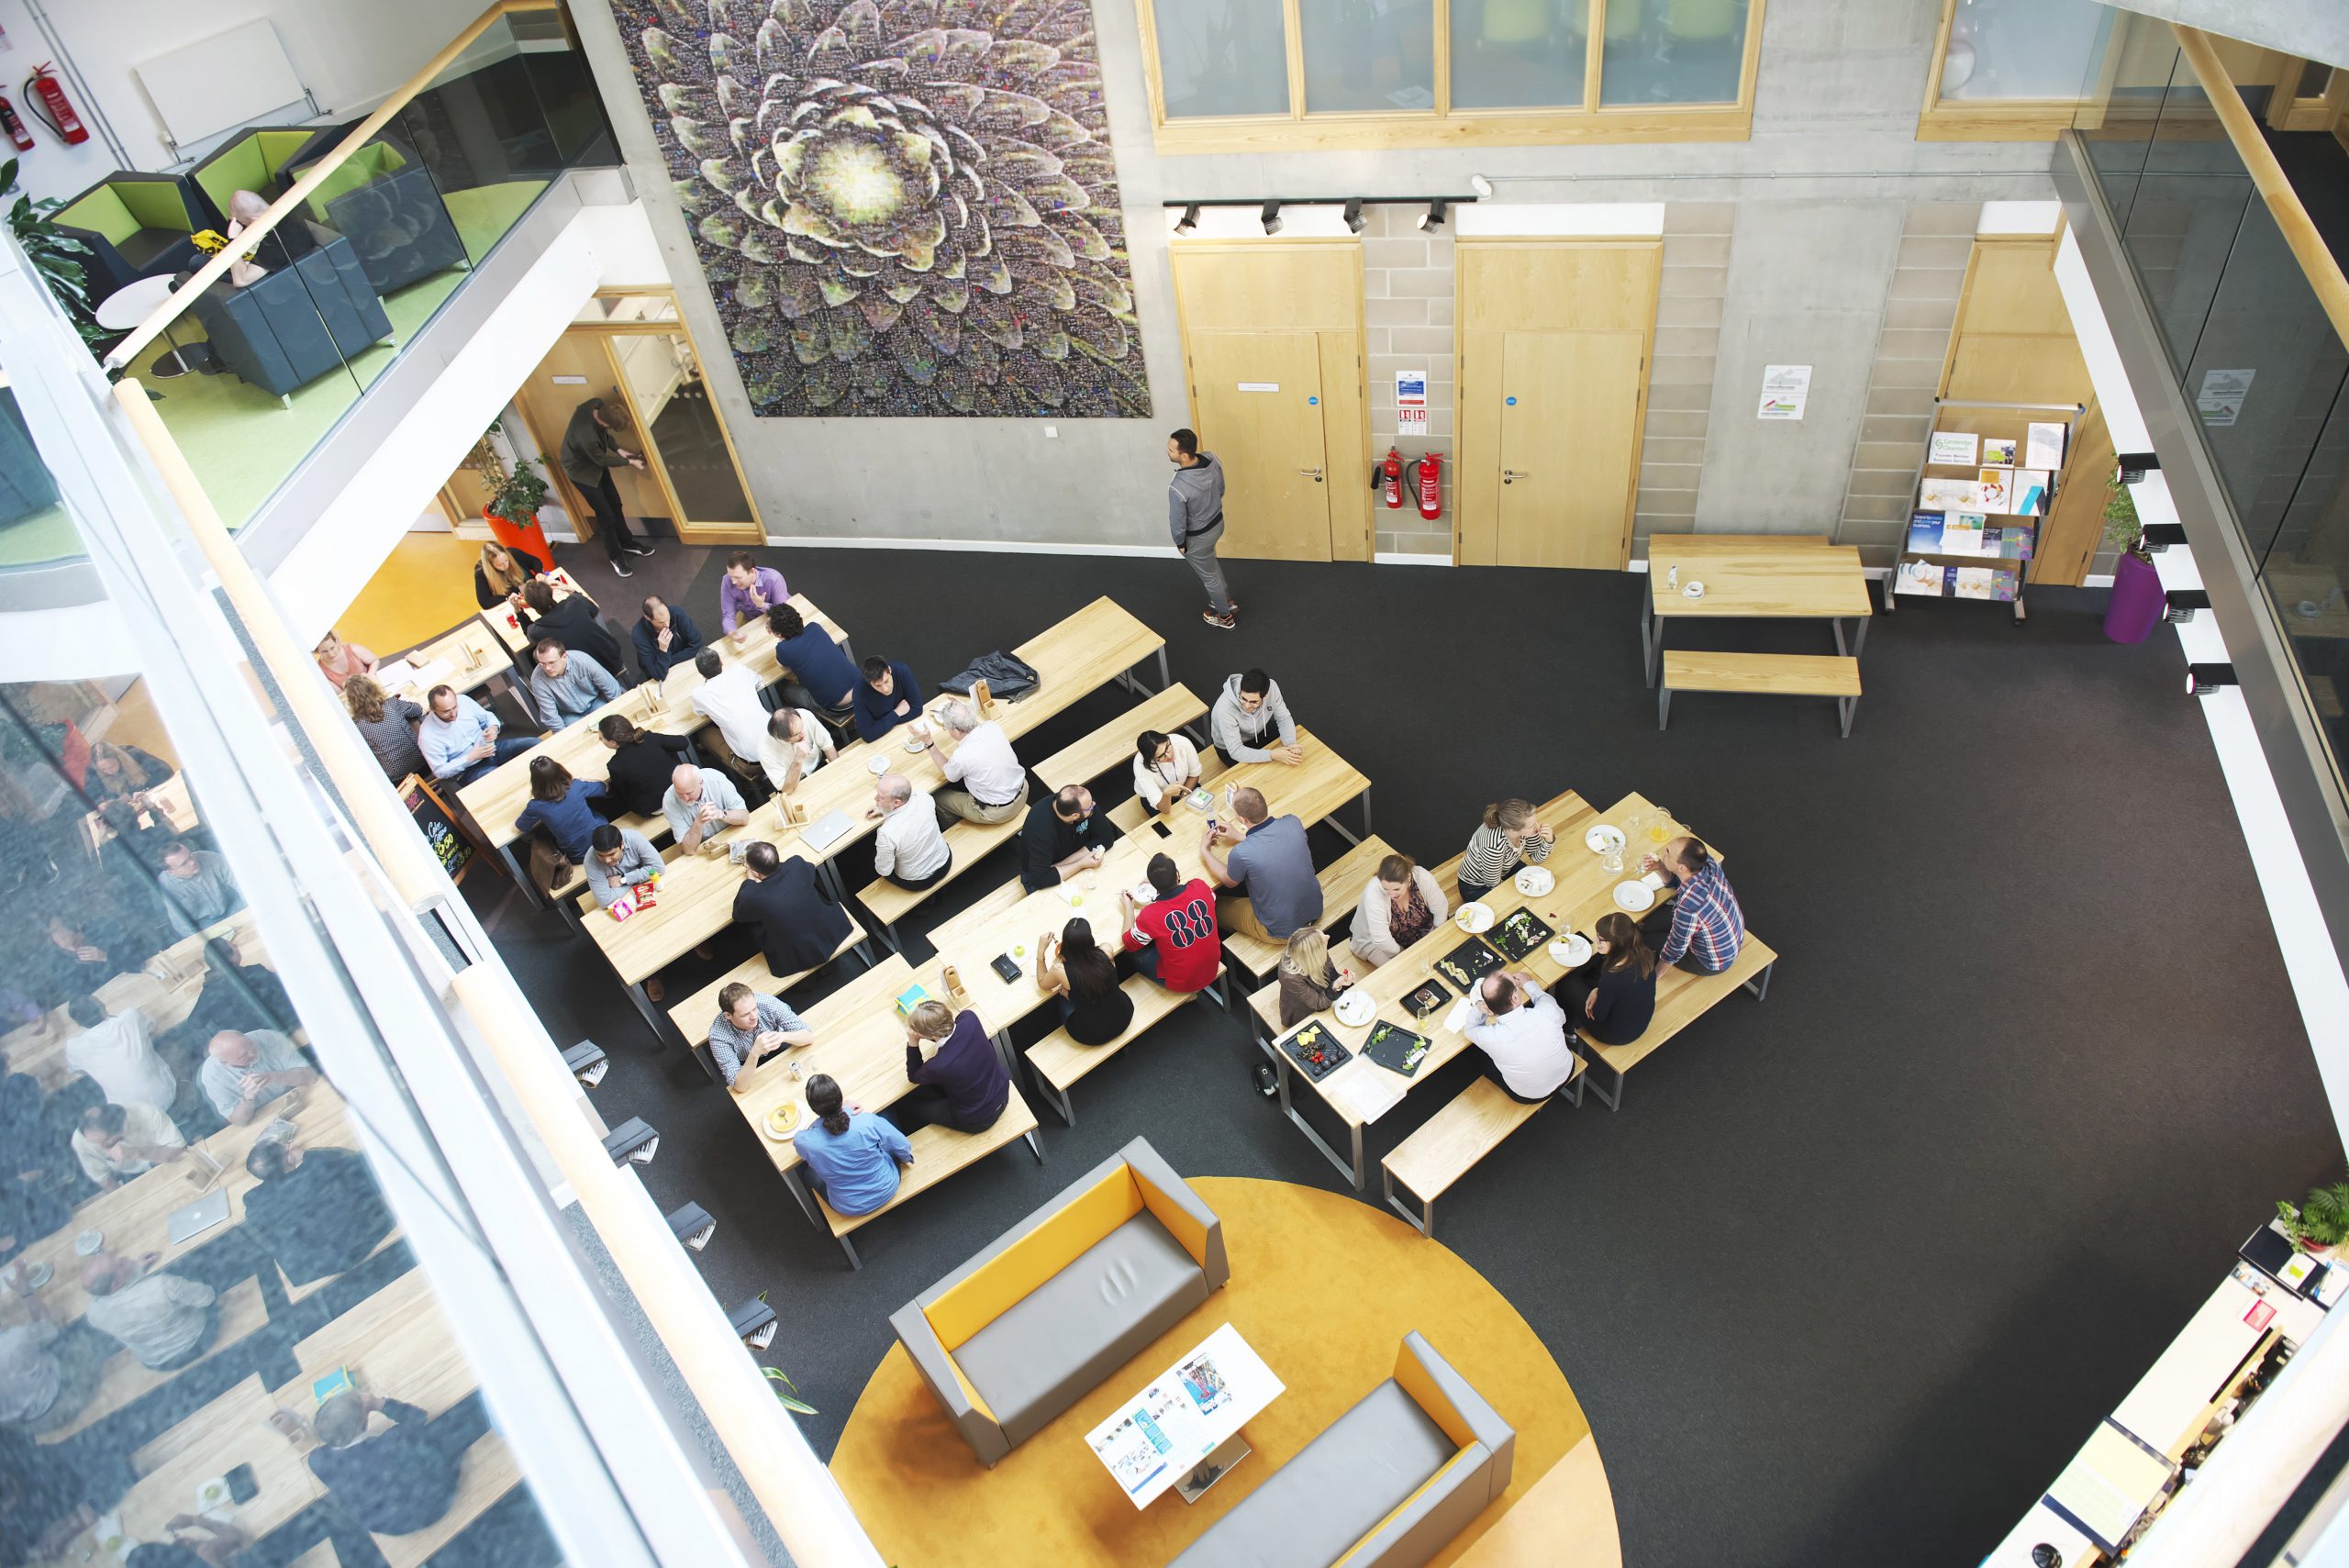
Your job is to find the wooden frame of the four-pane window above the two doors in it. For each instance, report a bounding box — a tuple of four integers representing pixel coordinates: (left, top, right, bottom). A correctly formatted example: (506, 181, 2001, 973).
(1134, 0, 1766, 152)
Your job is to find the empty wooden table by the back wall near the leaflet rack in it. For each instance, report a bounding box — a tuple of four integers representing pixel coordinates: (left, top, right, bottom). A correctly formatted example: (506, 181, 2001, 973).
(1640, 533, 1875, 685)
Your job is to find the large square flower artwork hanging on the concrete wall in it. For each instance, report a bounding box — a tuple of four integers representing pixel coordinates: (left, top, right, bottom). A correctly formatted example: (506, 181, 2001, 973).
(613, 0, 1151, 417)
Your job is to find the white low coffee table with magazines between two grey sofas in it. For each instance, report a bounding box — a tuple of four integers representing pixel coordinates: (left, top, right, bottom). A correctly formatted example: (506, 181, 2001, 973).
(1085, 1324, 1287, 1509)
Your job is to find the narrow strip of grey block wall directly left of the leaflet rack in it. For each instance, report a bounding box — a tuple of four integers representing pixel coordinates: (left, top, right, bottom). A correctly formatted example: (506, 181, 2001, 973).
(1837, 202, 1983, 566)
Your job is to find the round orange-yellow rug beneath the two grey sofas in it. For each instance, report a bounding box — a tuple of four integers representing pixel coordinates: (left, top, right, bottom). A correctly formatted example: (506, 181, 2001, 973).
(831, 1176, 1620, 1568)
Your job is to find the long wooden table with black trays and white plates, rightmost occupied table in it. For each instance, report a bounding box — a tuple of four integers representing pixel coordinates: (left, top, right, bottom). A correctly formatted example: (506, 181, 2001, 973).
(1274, 791, 1712, 1190)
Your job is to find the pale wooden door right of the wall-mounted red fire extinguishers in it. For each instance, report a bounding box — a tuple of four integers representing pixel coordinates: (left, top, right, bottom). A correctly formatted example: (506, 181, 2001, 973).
(1454, 239, 1663, 571)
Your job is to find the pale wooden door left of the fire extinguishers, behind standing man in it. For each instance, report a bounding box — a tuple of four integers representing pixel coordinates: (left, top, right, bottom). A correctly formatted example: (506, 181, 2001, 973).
(1172, 239, 1372, 561)
